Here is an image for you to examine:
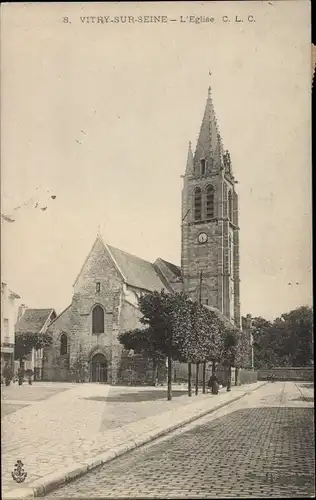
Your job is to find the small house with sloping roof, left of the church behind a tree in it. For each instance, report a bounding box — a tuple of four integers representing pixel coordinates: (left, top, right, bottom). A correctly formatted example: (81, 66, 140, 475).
(15, 308, 57, 380)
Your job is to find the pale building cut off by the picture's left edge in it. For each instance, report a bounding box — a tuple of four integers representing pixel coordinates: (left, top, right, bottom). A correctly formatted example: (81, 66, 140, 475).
(1, 282, 21, 373)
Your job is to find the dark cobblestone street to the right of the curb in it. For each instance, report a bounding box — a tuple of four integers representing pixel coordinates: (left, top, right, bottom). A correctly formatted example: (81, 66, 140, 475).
(46, 382, 315, 498)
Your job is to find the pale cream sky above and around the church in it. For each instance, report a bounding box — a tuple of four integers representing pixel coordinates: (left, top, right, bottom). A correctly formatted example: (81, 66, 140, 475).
(1, 0, 312, 319)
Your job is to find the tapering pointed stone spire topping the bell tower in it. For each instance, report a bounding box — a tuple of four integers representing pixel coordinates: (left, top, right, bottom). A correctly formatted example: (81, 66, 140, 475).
(194, 86, 223, 171)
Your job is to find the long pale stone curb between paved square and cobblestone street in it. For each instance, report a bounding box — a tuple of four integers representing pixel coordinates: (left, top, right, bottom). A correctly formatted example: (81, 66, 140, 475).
(2, 382, 267, 500)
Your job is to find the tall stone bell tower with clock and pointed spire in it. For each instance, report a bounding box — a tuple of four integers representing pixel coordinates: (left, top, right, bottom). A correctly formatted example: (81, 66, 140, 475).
(181, 87, 241, 327)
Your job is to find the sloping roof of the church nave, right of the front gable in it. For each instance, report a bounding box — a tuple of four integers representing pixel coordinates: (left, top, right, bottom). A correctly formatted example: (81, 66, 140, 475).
(107, 245, 170, 291)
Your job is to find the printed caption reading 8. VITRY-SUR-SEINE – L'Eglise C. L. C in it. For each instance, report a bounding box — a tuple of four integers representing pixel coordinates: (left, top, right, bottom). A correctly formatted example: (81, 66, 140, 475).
(62, 15, 255, 24)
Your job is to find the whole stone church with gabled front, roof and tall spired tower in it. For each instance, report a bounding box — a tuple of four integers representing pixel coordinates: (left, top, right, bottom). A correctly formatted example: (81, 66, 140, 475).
(43, 89, 241, 384)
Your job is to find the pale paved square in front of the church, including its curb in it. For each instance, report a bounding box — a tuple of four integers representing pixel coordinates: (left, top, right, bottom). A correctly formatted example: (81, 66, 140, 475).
(2, 382, 265, 499)
